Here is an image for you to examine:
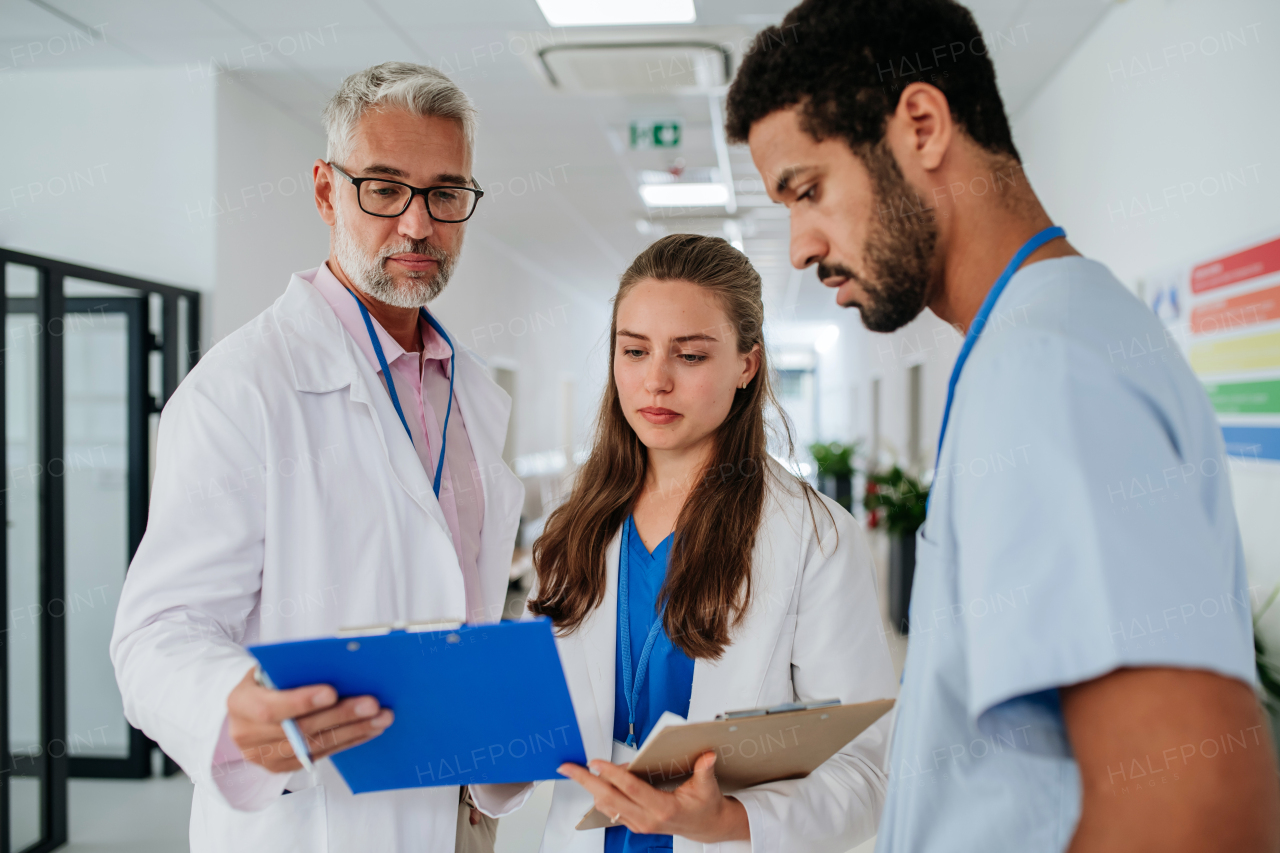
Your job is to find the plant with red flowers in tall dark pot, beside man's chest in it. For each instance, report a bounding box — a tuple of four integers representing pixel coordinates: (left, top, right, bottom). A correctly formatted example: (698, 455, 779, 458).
(863, 465, 929, 635)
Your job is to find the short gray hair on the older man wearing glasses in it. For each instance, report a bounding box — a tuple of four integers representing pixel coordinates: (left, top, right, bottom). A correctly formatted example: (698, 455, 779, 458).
(321, 63, 476, 164)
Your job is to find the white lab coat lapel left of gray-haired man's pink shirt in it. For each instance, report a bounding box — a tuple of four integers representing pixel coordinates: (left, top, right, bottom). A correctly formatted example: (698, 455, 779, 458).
(275, 275, 457, 545)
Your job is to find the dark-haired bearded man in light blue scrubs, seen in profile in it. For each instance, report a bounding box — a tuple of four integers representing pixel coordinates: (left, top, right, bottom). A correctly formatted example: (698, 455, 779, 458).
(728, 0, 1280, 853)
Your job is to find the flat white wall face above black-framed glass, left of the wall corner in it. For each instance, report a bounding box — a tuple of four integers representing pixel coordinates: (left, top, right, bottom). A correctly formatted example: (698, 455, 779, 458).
(0, 68, 214, 291)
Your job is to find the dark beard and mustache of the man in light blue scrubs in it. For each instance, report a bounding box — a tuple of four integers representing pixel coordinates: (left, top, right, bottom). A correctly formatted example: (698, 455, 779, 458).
(818, 140, 938, 332)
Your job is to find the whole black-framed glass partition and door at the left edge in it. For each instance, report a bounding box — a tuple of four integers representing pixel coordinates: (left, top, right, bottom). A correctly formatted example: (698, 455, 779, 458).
(0, 248, 200, 853)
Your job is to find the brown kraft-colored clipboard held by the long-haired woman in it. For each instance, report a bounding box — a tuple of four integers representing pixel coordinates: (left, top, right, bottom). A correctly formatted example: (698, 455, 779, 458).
(577, 699, 893, 830)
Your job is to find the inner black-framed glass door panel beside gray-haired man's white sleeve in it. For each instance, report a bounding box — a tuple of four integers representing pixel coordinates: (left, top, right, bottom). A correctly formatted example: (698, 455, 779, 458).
(63, 286, 152, 779)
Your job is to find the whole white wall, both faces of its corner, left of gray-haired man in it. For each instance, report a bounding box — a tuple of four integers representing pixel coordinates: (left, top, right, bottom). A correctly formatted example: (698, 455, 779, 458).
(0, 67, 328, 348)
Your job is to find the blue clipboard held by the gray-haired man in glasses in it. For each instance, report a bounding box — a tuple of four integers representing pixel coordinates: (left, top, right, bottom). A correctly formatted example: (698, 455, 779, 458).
(248, 619, 586, 794)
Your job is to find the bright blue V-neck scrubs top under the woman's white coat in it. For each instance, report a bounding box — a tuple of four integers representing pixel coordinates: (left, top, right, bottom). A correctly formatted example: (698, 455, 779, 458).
(604, 516, 694, 853)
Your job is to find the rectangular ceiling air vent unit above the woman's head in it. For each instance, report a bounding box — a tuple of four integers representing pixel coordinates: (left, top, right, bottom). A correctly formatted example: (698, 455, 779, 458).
(538, 41, 730, 95)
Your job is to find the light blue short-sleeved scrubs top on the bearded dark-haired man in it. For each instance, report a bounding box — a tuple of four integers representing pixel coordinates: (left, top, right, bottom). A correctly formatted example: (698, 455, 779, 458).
(876, 257, 1256, 853)
